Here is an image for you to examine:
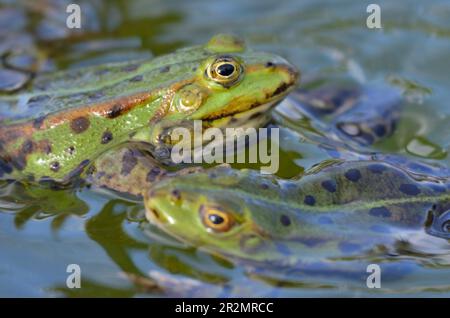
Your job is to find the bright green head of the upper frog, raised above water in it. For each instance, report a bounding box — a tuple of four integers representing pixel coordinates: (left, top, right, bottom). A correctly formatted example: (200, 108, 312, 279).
(135, 34, 299, 148)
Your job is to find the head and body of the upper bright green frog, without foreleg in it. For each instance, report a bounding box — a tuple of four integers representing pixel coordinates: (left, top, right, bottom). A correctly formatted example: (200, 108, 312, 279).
(0, 35, 299, 183)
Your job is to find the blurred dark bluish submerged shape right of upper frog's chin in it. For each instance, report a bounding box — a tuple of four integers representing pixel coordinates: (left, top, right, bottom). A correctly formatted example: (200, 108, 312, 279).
(274, 84, 402, 147)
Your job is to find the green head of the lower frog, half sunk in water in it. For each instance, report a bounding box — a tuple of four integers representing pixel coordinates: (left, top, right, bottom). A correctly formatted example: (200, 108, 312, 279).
(144, 166, 317, 263)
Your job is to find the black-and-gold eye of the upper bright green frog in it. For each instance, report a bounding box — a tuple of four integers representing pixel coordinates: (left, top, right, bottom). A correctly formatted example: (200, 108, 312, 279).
(206, 56, 242, 87)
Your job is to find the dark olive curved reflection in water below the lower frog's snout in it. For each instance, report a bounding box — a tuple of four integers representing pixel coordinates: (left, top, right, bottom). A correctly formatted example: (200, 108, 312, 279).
(76, 200, 234, 297)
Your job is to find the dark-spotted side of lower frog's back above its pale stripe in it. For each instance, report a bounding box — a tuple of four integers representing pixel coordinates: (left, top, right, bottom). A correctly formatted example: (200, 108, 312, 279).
(157, 161, 450, 220)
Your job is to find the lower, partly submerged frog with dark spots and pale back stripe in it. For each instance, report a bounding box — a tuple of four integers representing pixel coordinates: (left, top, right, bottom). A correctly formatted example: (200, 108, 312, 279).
(145, 161, 450, 266)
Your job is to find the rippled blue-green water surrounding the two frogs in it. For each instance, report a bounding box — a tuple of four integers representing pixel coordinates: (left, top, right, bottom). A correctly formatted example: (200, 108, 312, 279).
(0, 0, 450, 297)
